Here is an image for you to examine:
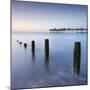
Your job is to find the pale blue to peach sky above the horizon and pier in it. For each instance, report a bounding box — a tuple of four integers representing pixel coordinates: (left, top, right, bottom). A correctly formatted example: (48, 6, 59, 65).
(11, 0, 87, 32)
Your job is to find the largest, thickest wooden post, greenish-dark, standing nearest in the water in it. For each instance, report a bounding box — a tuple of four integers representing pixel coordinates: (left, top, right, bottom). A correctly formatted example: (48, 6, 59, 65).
(73, 42, 81, 74)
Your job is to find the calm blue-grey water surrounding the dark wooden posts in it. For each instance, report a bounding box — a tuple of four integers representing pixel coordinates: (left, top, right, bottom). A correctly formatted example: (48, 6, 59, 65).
(11, 32, 87, 89)
